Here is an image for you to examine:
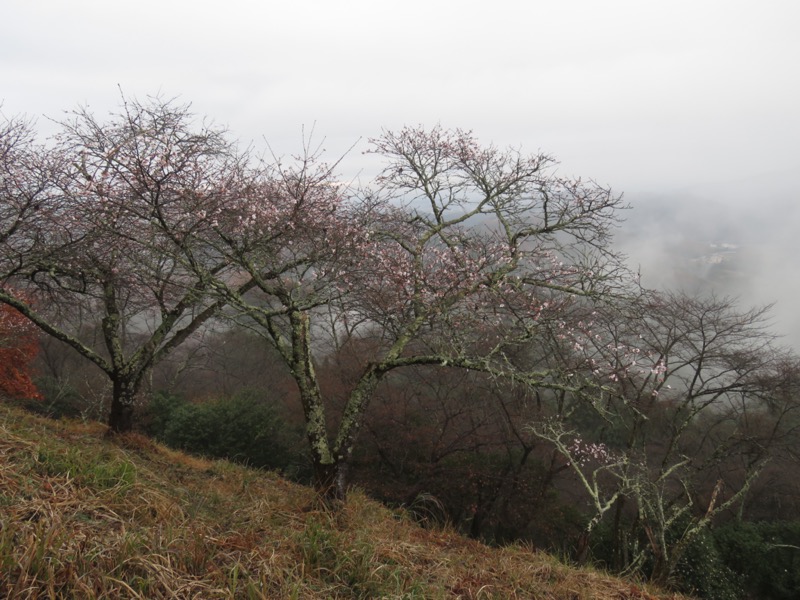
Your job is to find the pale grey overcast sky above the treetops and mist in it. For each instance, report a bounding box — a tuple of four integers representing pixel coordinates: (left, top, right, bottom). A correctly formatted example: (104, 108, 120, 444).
(0, 0, 800, 337)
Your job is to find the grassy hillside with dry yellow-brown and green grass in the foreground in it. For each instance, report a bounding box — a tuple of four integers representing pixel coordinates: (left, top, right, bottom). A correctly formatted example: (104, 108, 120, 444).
(0, 405, 688, 599)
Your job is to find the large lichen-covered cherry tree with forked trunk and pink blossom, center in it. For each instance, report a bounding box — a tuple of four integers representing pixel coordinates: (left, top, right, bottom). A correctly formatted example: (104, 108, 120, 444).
(202, 127, 624, 503)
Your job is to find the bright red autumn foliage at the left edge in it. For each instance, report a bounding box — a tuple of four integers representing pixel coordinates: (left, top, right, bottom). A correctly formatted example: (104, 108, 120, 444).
(0, 304, 41, 398)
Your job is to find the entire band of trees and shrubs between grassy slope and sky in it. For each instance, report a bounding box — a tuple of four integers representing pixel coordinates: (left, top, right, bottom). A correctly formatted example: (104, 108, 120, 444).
(0, 99, 800, 598)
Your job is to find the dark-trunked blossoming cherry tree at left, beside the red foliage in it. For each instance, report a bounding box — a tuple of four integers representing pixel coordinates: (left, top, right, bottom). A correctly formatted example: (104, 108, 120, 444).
(0, 99, 248, 432)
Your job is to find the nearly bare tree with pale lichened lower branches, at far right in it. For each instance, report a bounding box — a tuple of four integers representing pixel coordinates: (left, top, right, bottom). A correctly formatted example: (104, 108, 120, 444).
(535, 292, 790, 582)
